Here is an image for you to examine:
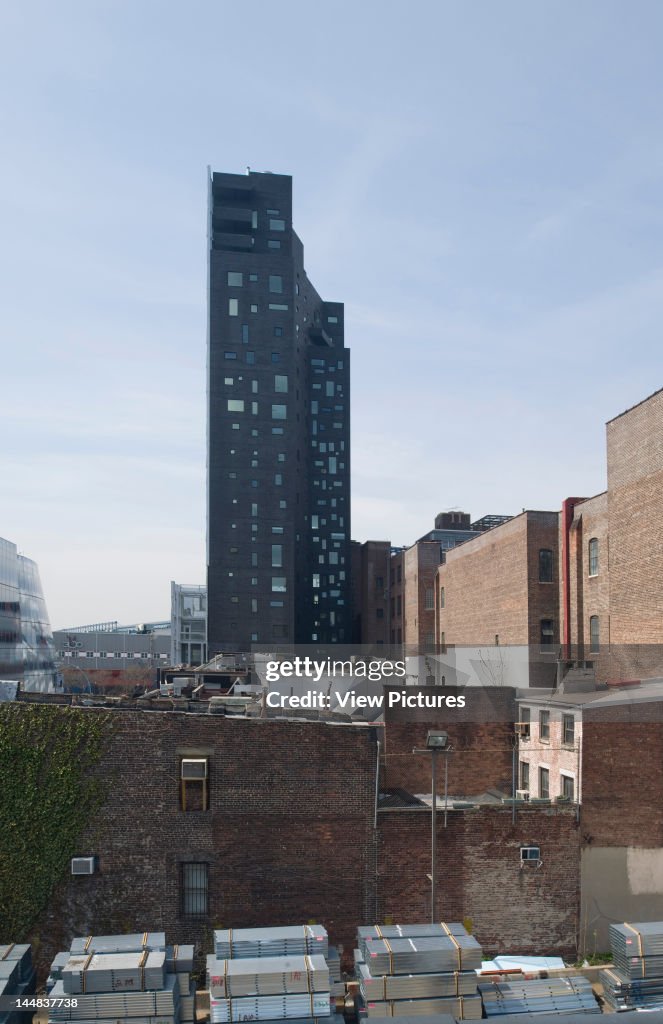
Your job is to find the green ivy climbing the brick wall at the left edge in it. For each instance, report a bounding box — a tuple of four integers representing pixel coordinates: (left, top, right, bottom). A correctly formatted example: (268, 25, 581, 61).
(0, 703, 114, 942)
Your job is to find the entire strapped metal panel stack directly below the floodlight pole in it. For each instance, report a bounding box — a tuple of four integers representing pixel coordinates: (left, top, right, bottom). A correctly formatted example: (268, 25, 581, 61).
(355, 924, 482, 1020)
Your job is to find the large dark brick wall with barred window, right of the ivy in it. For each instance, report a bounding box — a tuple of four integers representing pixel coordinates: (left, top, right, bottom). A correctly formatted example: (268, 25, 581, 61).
(39, 709, 375, 958)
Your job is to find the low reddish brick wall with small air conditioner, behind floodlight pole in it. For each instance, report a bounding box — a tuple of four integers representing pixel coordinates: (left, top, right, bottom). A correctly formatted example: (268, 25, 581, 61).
(378, 807, 580, 956)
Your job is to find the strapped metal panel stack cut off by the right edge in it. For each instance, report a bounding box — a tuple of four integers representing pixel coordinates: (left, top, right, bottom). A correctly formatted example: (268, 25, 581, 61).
(598, 922, 663, 1010)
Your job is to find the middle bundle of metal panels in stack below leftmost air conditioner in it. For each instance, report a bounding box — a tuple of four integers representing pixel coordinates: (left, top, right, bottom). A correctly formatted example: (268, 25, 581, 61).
(63, 949, 166, 995)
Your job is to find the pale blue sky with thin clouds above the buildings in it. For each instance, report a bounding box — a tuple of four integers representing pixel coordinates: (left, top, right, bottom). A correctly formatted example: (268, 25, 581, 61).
(0, 0, 663, 628)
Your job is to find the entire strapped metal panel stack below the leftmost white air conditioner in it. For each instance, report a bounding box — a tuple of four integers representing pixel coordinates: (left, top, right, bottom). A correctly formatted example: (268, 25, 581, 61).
(48, 932, 196, 1024)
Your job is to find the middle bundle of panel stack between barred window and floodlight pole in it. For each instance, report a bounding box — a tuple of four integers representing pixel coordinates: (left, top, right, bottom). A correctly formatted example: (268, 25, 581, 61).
(207, 956, 329, 999)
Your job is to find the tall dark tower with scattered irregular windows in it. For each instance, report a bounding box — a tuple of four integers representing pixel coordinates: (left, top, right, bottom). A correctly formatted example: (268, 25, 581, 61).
(207, 165, 351, 655)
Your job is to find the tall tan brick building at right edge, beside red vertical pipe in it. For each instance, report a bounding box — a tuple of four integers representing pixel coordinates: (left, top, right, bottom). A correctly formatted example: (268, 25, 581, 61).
(561, 390, 663, 679)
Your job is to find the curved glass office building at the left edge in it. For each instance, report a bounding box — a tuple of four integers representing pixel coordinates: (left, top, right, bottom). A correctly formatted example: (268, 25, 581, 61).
(0, 538, 59, 692)
